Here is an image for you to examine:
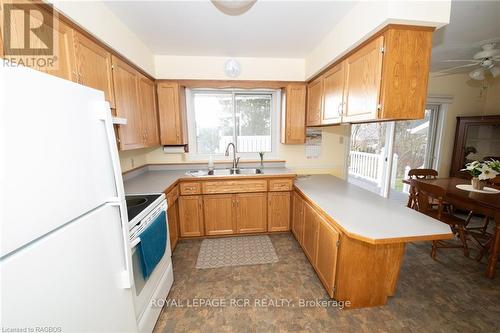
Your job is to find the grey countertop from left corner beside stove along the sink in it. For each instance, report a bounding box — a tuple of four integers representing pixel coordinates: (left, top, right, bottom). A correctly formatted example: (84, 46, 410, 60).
(123, 167, 295, 194)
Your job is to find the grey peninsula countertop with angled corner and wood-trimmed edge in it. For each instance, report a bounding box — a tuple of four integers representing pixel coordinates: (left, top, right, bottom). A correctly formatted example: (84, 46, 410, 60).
(295, 175, 452, 244)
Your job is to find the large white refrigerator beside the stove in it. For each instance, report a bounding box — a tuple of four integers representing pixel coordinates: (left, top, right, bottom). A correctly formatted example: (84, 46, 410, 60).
(0, 65, 137, 332)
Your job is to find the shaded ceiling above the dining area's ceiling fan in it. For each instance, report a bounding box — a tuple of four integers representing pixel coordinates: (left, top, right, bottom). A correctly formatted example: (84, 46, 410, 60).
(431, 1, 500, 72)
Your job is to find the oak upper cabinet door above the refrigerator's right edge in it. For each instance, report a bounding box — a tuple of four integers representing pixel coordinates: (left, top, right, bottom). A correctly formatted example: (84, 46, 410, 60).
(75, 32, 115, 109)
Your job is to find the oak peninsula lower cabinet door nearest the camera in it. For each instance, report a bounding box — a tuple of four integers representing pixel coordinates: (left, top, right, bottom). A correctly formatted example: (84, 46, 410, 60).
(316, 216, 340, 297)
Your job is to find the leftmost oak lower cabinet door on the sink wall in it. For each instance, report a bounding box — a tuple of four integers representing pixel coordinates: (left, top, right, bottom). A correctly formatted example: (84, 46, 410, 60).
(178, 195, 204, 237)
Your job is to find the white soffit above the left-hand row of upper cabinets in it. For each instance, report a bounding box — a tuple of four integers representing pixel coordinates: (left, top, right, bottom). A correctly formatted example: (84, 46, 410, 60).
(48, 0, 155, 76)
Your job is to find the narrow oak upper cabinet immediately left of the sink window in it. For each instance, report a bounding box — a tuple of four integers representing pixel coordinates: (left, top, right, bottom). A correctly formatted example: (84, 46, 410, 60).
(158, 82, 188, 146)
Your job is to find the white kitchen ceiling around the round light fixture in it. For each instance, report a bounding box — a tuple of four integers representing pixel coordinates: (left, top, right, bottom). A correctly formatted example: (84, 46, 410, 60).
(106, 0, 356, 58)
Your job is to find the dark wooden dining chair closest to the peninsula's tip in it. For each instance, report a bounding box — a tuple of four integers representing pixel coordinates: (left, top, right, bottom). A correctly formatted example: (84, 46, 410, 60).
(410, 179, 469, 259)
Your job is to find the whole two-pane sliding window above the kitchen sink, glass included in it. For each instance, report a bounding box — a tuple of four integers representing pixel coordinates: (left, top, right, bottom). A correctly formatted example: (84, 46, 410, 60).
(186, 89, 280, 161)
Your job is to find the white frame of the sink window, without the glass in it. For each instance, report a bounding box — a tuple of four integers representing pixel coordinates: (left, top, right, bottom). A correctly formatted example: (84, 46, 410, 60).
(186, 88, 281, 161)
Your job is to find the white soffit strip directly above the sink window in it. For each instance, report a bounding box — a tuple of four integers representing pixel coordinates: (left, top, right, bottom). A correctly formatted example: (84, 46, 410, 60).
(155, 55, 305, 81)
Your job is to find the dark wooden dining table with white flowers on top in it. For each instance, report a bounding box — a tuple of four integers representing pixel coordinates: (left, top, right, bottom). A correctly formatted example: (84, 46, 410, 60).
(403, 178, 500, 279)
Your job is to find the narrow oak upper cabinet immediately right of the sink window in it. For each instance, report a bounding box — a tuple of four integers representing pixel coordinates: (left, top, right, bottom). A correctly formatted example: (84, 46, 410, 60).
(281, 84, 307, 144)
